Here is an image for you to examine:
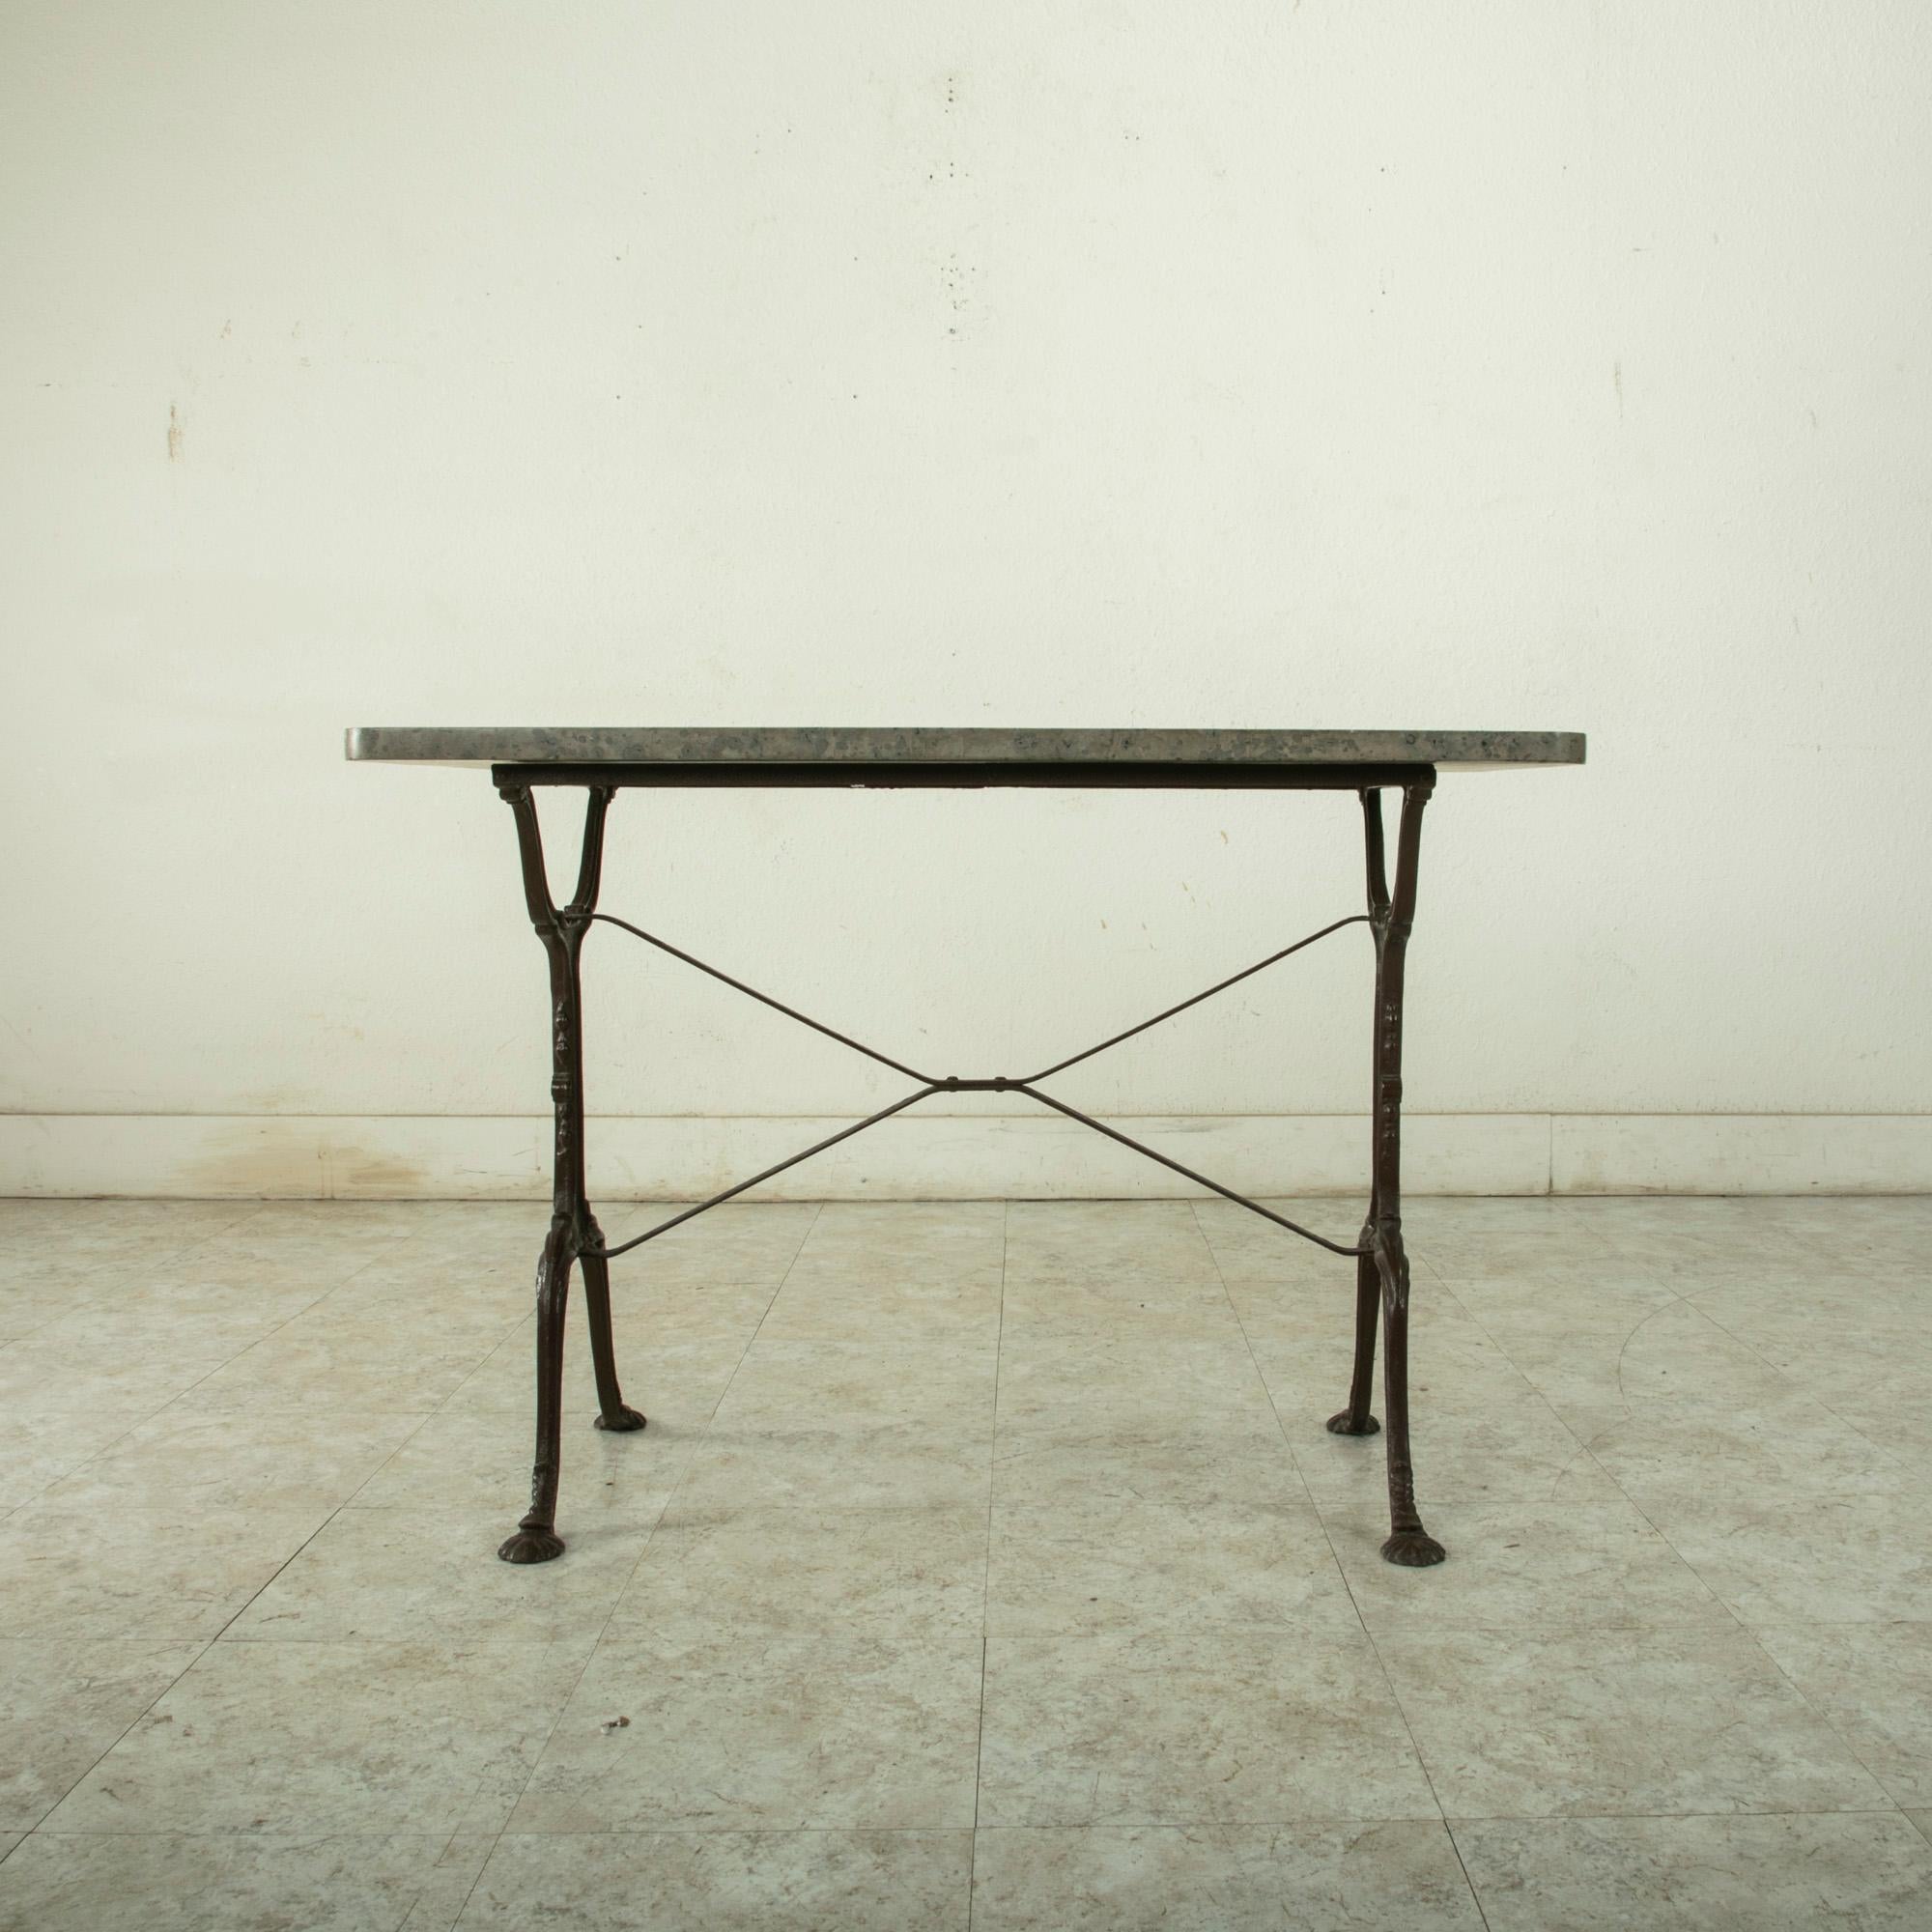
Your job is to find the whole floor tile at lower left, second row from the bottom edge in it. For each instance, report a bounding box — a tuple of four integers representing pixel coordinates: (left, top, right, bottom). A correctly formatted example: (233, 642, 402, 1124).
(41, 1642, 585, 1839)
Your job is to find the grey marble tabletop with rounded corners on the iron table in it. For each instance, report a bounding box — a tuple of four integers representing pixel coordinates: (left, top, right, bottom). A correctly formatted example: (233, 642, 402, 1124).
(346, 724, 1584, 771)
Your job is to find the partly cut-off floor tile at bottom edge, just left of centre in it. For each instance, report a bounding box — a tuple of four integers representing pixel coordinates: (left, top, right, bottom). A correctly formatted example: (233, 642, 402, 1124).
(460, 1832, 972, 1932)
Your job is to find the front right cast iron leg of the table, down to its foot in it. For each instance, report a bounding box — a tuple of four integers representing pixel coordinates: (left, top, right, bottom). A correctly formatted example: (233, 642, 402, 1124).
(1370, 773, 1445, 1567)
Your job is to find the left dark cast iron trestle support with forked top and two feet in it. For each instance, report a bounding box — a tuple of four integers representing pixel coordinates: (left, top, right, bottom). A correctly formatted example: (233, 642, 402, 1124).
(497, 784, 643, 1563)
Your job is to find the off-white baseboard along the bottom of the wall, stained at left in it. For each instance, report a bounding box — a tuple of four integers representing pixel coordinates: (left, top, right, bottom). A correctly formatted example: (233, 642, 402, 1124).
(0, 1113, 1932, 1200)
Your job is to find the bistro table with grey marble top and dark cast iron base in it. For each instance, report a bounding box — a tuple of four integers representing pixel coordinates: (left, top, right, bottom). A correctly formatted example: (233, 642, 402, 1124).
(348, 724, 1584, 1567)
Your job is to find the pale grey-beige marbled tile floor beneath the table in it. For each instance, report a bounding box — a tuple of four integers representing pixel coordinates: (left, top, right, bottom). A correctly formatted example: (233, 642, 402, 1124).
(0, 1200, 1932, 1932)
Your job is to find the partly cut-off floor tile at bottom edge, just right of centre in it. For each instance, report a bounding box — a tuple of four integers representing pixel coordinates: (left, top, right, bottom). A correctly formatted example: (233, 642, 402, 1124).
(972, 1818, 1484, 1932)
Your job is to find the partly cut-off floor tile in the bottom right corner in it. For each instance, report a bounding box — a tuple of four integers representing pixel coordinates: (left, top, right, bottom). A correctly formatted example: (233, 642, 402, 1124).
(1453, 1812, 1932, 1932)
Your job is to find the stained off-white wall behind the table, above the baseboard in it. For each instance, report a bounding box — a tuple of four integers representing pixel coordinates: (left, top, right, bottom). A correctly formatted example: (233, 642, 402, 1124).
(0, 0, 1932, 1188)
